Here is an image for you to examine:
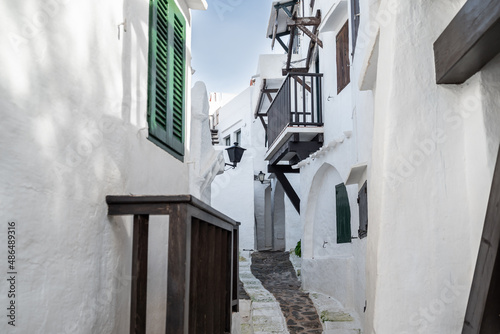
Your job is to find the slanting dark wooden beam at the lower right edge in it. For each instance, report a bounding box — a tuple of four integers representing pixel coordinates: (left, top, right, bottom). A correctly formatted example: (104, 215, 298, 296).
(462, 147, 500, 334)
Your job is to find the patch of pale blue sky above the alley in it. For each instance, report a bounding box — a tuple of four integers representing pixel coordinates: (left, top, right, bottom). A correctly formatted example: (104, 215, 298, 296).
(191, 0, 283, 94)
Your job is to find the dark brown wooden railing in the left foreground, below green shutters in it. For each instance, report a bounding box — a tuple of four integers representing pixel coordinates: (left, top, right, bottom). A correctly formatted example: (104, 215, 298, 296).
(106, 195, 239, 334)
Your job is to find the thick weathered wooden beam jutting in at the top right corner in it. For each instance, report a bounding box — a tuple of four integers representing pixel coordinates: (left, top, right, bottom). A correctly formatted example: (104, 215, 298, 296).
(434, 0, 500, 84)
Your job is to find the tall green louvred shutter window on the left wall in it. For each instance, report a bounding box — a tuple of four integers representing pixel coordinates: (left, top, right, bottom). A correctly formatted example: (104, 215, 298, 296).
(148, 0, 186, 160)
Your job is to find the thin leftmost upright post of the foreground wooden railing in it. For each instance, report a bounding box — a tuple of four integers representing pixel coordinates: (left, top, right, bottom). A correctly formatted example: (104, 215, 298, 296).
(130, 215, 149, 334)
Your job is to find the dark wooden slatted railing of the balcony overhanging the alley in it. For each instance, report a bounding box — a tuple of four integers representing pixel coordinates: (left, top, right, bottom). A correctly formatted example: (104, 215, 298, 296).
(267, 73, 323, 146)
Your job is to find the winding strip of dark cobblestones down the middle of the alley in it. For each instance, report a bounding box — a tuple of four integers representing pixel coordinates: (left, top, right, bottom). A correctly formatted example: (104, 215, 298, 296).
(251, 252, 323, 334)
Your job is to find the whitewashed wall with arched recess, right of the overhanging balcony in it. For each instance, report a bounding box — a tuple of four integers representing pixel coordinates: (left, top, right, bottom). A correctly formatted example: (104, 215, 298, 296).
(299, 1, 373, 321)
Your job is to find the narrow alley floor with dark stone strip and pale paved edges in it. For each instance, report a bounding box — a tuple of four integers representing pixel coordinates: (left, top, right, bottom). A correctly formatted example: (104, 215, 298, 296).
(240, 251, 360, 334)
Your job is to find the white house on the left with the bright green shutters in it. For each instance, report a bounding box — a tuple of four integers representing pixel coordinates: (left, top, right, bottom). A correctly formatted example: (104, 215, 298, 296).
(0, 0, 242, 333)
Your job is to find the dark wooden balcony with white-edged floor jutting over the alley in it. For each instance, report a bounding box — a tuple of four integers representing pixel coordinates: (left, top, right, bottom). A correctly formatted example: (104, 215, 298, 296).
(265, 73, 323, 165)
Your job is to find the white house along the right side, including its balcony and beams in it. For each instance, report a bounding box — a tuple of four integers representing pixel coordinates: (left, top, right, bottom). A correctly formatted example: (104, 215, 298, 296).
(260, 0, 500, 334)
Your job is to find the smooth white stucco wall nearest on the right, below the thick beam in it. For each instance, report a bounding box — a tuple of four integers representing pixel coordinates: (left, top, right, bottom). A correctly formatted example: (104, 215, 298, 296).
(366, 1, 500, 333)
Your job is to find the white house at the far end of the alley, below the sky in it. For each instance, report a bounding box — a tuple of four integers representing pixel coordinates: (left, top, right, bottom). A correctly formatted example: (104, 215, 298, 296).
(212, 54, 300, 250)
